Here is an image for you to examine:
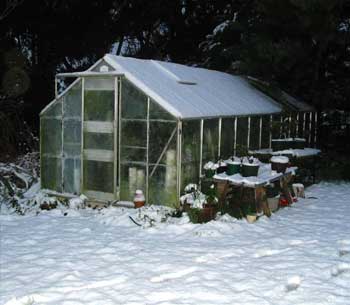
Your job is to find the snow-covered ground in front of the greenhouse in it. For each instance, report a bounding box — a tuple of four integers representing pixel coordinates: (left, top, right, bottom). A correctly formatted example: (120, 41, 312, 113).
(0, 183, 350, 305)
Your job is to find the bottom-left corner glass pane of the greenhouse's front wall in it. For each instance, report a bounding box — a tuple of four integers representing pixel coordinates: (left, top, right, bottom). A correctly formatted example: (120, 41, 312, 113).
(40, 156, 62, 192)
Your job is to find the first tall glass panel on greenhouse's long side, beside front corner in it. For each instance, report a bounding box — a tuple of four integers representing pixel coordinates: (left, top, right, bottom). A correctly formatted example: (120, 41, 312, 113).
(181, 120, 200, 191)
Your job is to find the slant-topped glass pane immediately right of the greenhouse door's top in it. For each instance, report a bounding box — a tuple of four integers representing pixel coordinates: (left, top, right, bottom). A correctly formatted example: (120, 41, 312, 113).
(121, 77, 147, 119)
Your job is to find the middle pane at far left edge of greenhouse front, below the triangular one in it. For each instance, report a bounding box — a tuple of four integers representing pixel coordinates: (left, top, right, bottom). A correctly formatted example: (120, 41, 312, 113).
(40, 118, 62, 156)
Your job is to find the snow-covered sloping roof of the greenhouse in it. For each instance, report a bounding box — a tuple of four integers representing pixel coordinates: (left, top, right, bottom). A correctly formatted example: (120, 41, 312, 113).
(104, 54, 281, 119)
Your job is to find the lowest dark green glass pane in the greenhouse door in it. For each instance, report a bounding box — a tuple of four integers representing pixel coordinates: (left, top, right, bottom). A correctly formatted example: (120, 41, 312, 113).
(83, 160, 114, 193)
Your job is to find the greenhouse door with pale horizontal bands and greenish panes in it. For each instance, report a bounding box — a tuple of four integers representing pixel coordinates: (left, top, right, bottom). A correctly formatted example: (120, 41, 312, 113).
(82, 77, 118, 201)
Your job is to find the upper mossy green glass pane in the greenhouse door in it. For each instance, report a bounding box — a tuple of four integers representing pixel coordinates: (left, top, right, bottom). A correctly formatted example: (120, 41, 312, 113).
(84, 90, 114, 122)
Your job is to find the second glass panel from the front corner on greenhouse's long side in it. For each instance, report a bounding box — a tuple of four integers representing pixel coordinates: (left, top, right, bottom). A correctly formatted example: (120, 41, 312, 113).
(203, 119, 219, 165)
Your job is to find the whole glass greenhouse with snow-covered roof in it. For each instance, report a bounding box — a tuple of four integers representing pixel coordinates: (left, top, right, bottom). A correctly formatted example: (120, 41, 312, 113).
(40, 54, 317, 206)
